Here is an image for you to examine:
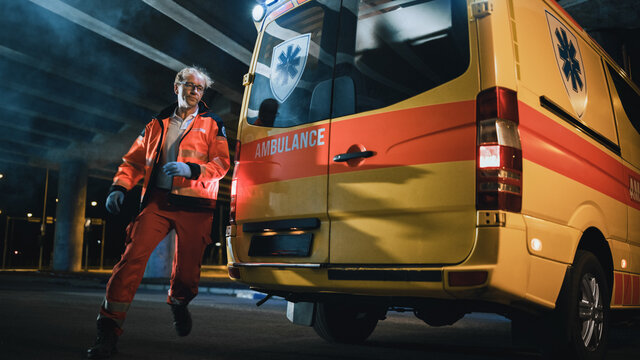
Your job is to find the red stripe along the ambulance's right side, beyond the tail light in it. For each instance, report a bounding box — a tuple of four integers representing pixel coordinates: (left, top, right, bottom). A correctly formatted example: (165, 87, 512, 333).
(518, 102, 640, 210)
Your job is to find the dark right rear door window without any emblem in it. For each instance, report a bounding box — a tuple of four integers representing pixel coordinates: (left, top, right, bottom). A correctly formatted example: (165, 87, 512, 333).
(334, 0, 470, 117)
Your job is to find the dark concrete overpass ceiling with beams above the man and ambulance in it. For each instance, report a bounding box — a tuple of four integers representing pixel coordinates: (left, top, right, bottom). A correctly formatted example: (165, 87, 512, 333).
(0, 0, 640, 215)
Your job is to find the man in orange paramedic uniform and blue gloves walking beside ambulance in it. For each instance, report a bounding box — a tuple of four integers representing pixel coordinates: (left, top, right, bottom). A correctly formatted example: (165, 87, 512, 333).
(87, 67, 230, 359)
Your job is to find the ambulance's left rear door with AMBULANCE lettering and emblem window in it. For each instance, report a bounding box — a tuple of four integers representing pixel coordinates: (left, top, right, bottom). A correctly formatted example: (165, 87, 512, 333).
(234, 2, 339, 267)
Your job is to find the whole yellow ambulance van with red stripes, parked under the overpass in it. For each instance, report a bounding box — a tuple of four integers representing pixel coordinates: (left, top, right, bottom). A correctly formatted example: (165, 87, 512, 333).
(226, 0, 640, 359)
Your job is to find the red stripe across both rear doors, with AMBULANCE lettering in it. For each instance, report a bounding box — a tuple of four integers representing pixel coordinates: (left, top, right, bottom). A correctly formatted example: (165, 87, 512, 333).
(238, 100, 476, 186)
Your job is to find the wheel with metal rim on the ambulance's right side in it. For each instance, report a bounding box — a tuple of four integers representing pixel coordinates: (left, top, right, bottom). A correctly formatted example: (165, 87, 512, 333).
(547, 250, 611, 360)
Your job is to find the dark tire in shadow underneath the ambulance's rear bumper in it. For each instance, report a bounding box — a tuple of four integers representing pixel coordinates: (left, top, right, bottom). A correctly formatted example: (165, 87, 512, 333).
(313, 303, 384, 344)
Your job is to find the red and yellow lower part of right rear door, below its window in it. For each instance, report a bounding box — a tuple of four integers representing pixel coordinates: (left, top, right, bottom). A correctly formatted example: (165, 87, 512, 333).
(329, 101, 476, 264)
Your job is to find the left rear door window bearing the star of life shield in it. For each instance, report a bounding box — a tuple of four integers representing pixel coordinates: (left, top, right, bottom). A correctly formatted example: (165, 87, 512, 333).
(247, 2, 339, 127)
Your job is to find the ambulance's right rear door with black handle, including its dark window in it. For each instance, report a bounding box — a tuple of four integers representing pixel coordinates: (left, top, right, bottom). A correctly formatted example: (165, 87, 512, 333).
(328, 0, 479, 265)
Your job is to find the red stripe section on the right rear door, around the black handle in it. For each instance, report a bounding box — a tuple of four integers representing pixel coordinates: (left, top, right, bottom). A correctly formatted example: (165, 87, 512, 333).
(329, 101, 476, 174)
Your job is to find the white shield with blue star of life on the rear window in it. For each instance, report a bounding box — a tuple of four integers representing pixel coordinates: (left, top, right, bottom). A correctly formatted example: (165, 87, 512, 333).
(269, 34, 311, 103)
